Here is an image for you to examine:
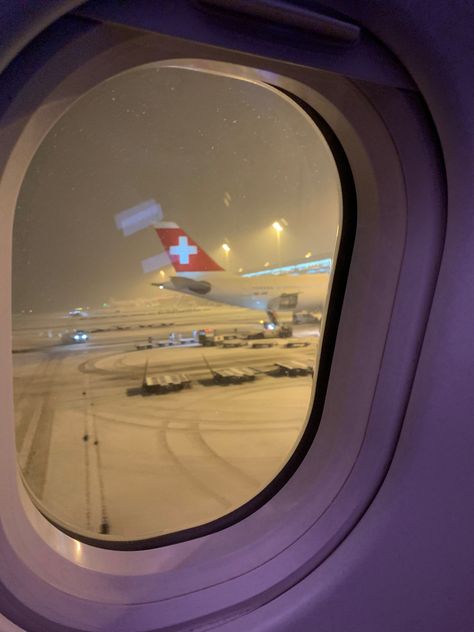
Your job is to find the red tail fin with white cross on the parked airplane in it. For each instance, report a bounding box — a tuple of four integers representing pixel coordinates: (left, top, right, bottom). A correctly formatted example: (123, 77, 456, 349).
(155, 222, 223, 272)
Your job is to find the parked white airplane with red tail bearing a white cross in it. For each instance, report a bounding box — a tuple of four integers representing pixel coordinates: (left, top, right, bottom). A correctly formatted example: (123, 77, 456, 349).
(153, 222, 329, 320)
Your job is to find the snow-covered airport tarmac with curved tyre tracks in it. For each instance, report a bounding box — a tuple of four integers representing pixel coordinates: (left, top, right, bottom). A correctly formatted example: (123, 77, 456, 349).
(14, 310, 317, 539)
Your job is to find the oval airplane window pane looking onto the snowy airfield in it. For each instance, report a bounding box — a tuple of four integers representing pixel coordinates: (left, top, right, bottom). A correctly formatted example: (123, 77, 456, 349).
(13, 64, 342, 541)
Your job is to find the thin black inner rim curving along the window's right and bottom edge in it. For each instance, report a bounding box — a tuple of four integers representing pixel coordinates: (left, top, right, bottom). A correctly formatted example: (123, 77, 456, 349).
(10, 60, 357, 551)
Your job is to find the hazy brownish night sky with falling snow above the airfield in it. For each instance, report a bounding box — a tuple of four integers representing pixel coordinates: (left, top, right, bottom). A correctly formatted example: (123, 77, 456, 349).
(13, 66, 341, 312)
